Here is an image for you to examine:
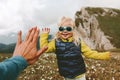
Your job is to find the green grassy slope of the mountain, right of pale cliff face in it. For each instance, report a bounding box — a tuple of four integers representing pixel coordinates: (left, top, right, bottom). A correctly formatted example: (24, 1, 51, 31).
(86, 7, 120, 48)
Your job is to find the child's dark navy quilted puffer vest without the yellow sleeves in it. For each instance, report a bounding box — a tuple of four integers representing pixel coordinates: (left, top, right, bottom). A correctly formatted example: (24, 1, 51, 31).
(56, 40, 86, 78)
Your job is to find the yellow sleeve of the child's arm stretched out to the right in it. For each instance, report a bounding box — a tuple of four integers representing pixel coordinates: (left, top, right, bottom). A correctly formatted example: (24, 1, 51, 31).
(81, 41, 110, 59)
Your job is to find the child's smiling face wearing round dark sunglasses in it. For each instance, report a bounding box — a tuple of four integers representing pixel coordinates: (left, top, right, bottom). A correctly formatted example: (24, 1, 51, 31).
(58, 26, 73, 39)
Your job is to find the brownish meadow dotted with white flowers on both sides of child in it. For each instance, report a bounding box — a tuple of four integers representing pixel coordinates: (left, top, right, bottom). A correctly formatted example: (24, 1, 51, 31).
(0, 52, 120, 80)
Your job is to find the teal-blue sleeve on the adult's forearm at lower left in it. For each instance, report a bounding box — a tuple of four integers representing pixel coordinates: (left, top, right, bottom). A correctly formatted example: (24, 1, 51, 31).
(0, 56, 28, 80)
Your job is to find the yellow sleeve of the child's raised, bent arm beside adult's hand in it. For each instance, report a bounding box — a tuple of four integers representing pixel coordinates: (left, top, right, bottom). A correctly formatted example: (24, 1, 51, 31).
(40, 33, 55, 53)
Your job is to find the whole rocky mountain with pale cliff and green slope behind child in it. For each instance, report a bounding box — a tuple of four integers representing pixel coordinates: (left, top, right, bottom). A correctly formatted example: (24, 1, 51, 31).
(75, 7, 120, 51)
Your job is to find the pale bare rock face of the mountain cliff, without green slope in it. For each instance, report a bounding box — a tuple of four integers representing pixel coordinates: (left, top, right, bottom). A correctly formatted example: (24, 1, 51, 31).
(75, 8, 117, 51)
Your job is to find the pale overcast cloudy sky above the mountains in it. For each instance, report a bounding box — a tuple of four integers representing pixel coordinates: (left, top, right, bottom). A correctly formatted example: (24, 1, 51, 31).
(0, 0, 120, 44)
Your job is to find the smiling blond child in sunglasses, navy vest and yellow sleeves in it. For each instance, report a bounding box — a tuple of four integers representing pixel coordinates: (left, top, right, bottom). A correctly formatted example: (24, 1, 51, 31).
(40, 17, 109, 80)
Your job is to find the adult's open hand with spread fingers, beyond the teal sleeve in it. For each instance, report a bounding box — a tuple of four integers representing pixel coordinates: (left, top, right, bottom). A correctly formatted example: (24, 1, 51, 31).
(13, 27, 47, 64)
